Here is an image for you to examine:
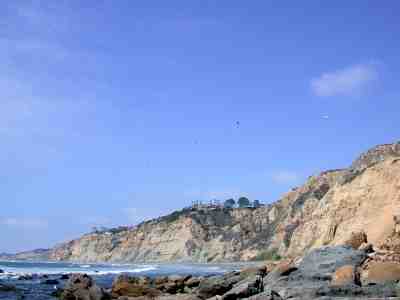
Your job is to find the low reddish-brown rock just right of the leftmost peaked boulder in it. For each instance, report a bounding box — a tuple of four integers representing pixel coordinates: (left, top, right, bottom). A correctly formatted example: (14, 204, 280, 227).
(111, 275, 161, 298)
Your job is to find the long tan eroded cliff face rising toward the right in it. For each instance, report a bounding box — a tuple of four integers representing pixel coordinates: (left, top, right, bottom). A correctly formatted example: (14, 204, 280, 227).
(50, 143, 400, 262)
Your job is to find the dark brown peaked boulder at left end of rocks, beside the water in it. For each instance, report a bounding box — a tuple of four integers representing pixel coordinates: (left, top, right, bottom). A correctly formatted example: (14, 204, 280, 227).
(60, 274, 111, 300)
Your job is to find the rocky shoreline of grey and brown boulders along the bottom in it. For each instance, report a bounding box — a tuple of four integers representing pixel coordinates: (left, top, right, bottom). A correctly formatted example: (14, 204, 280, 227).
(0, 232, 400, 300)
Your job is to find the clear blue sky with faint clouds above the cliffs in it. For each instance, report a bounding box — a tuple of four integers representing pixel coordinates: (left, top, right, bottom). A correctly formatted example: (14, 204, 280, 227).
(0, 0, 400, 252)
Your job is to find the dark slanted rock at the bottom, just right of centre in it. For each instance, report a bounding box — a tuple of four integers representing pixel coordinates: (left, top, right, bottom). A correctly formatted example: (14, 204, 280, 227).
(197, 272, 241, 299)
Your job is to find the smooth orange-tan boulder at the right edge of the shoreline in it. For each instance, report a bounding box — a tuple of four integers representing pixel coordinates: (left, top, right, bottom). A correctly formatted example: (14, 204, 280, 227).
(361, 262, 400, 285)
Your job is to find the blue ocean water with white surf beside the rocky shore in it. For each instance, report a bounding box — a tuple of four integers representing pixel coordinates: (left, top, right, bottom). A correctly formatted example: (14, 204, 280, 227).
(0, 261, 242, 300)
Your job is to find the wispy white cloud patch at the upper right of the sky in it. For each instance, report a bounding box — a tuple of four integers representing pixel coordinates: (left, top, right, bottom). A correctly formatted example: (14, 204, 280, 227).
(311, 63, 378, 97)
